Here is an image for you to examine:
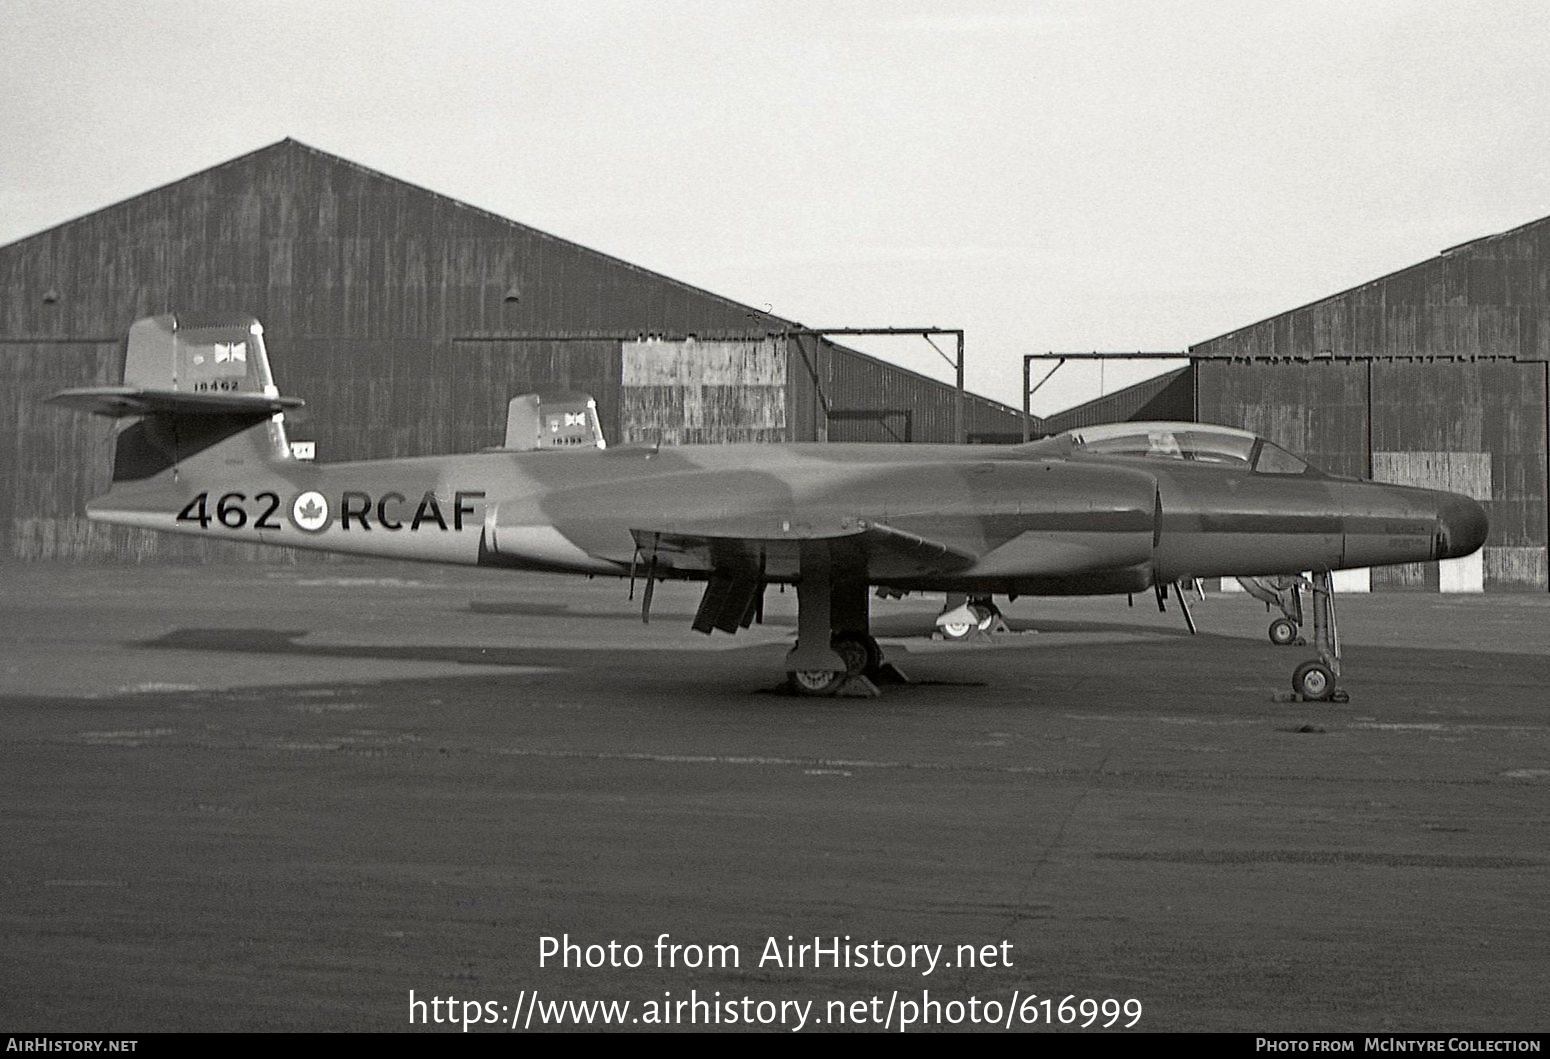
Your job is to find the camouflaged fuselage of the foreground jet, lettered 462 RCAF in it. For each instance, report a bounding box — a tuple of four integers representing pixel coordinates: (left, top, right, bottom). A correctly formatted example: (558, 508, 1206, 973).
(88, 434, 1485, 594)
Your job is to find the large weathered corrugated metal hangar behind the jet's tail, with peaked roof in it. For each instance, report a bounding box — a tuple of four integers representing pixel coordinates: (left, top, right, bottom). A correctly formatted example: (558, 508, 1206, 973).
(9, 140, 1041, 558)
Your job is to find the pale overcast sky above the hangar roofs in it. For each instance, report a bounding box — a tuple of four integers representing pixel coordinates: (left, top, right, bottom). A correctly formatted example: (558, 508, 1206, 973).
(0, 0, 1550, 412)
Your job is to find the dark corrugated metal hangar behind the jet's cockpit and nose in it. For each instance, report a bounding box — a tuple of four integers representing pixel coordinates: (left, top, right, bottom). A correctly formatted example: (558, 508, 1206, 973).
(1043, 217, 1550, 591)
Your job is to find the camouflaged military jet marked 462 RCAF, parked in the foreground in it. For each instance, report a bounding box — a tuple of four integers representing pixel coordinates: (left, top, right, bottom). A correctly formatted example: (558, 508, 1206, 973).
(50, 315, 1486, 699)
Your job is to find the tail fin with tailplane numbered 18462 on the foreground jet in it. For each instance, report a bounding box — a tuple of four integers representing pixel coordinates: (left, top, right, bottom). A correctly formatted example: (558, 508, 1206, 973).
(48, 313, 302, 482)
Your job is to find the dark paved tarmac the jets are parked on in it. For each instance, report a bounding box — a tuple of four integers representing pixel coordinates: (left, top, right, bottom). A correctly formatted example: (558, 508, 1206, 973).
(0, 563, 1550, 1034)
